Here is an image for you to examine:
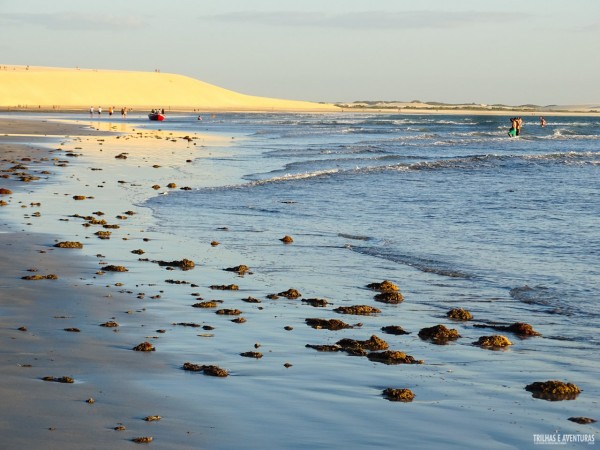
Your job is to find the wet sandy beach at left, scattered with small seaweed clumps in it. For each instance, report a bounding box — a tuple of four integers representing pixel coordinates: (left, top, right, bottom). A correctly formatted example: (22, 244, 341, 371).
(0, 119, 232, 449)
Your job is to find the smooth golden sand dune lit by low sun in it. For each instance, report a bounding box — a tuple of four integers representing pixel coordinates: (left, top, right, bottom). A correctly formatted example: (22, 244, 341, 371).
(0, 66, 337, 111)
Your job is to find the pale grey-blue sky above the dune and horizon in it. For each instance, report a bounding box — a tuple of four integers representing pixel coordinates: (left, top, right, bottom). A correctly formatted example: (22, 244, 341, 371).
(0, 0, 600, 105)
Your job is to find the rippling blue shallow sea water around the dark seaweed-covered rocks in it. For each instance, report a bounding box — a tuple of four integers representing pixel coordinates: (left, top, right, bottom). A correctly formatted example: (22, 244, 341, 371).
(3, 110, 600, 449)
